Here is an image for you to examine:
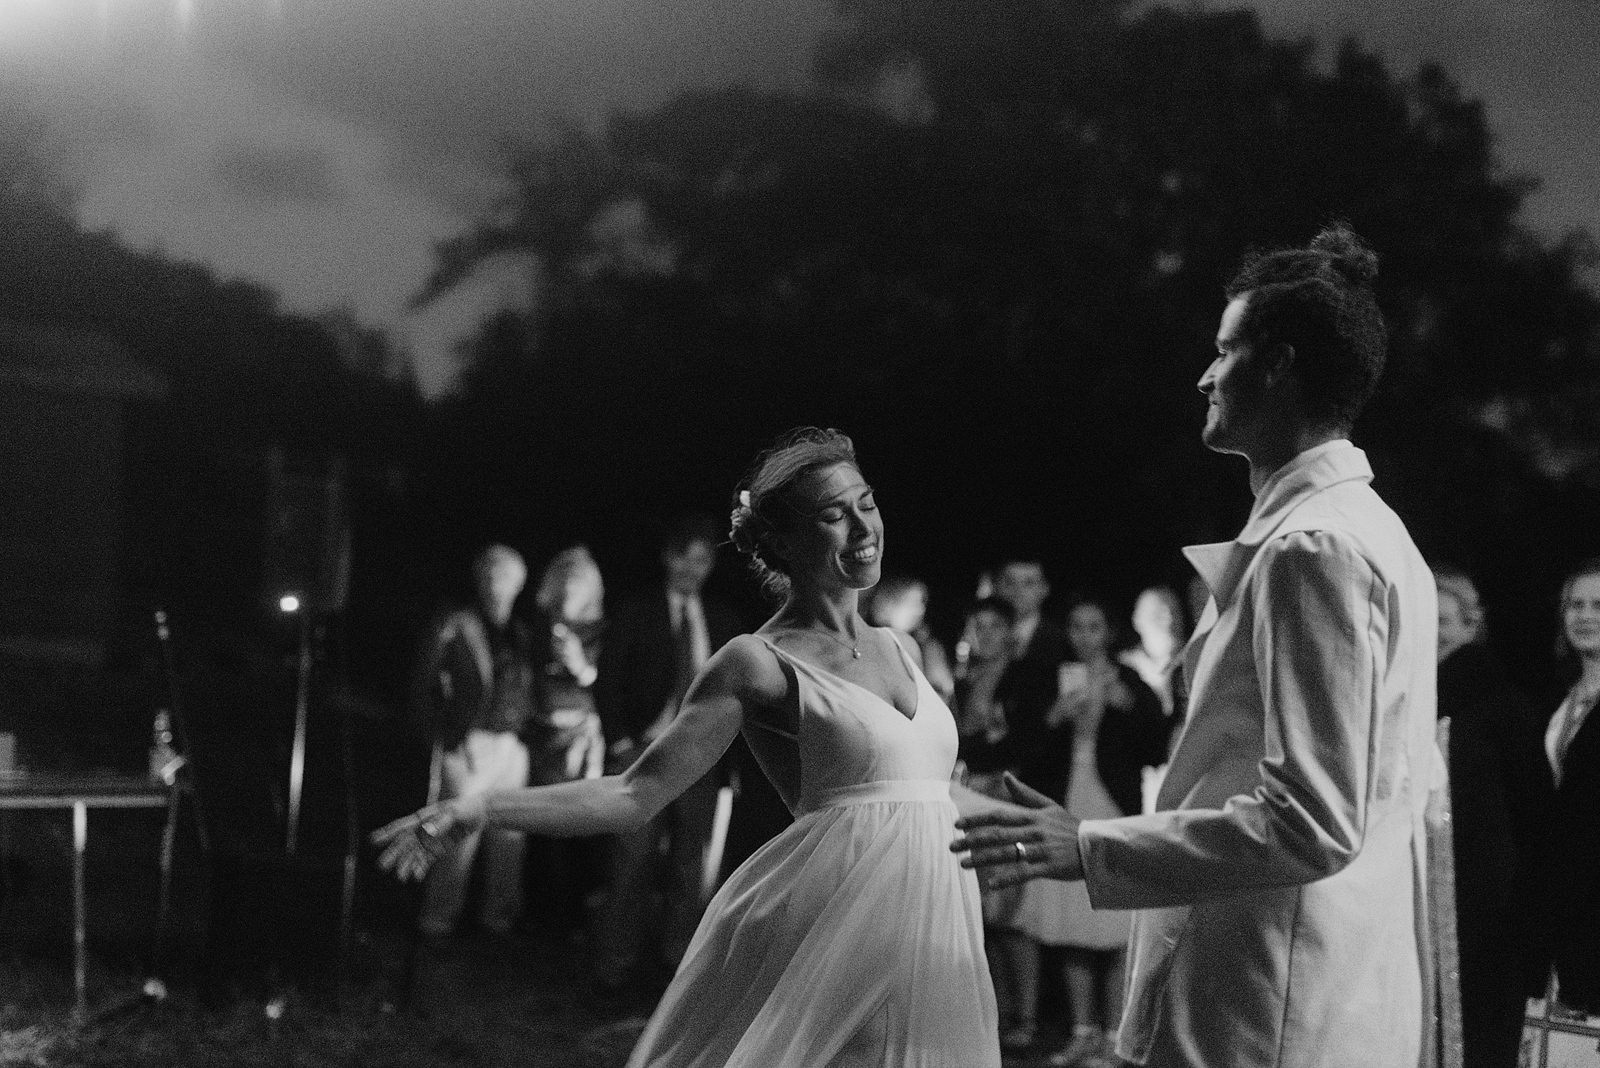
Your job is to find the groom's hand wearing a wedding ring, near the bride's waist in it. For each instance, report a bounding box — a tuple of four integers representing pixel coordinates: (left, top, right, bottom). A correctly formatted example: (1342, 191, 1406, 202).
(950, 772, 1083, 887)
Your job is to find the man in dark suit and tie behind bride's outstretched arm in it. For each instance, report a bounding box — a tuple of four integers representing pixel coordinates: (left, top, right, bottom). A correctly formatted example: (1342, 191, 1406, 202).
(595, 515, 741, 986)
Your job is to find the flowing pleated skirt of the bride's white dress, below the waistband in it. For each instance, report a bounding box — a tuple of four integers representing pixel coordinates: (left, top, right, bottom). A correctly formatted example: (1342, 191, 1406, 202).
(627, 780, 1000, 1068)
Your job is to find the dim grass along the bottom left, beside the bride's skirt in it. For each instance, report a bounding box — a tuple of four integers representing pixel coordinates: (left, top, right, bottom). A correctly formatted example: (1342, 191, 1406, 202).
(0, 935, 643, 1068)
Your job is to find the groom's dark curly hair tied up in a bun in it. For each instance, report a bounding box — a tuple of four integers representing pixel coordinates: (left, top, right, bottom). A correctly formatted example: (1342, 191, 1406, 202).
(1227, 222, 1389, 428)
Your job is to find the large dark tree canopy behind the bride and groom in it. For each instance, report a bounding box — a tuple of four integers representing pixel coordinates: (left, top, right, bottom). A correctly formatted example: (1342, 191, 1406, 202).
(422, 0, 1600, 658)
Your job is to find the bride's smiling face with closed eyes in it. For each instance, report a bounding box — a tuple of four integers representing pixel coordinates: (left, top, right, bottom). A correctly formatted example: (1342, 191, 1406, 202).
(781, 464, 883, 590)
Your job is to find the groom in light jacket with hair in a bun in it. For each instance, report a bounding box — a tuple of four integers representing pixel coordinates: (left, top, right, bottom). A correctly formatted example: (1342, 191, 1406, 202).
(952, 225, 1437, 1068)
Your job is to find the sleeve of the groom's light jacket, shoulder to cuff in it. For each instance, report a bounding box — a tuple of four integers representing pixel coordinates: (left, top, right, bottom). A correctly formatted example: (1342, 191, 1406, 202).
(1078, 532, 1389, 908)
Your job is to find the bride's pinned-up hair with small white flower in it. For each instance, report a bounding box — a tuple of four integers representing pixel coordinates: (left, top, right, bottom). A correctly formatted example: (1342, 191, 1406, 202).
(728, 427, 861, 601)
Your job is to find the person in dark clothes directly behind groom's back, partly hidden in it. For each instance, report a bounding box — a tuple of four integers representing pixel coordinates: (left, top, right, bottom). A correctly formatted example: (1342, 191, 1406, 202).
(1434, 568, 1550, 1068)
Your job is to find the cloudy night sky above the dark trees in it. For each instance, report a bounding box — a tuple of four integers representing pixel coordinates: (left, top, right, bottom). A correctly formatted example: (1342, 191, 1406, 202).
(0, 0, 1600, 392)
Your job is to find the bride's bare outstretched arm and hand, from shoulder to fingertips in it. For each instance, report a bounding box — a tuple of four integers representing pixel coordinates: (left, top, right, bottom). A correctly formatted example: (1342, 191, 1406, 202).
(373, 638, 787, 879)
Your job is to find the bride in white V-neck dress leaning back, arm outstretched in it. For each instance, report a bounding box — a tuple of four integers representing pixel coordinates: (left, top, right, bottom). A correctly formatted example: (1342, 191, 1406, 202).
(373, 428, 1029, 1068)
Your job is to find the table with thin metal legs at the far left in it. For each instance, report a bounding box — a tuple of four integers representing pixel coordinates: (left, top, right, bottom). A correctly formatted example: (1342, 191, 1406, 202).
(0, 772, 179, 1020)
